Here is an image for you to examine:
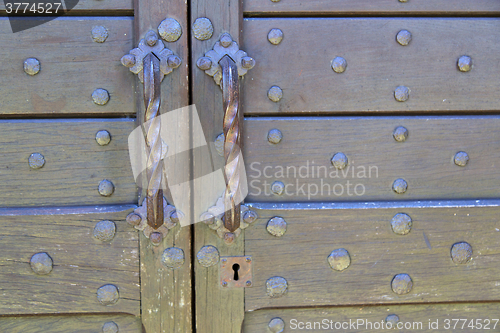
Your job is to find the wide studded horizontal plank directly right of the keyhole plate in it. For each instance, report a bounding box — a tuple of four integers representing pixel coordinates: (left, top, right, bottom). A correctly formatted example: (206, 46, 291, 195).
(245, 200, 500, 311)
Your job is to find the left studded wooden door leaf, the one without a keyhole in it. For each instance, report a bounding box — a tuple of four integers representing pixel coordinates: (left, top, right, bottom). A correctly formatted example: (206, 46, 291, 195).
(0, 0, 192, 333)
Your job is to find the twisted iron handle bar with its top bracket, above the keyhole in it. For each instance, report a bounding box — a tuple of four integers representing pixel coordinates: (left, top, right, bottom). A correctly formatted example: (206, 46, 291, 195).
(196, 33, 255, 232)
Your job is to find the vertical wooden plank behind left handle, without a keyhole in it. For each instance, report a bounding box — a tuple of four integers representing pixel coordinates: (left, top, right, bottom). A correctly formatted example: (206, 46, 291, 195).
(135, 0, 193, 333)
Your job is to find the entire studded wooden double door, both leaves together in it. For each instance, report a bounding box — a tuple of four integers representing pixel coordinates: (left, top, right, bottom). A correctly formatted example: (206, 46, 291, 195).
(0, 0, 500, 333)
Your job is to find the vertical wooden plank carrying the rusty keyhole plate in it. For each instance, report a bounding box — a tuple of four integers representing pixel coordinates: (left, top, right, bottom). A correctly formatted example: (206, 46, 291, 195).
(191, 0, 244, 333)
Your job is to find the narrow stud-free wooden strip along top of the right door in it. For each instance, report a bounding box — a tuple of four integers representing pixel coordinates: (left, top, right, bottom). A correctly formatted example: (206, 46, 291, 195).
(243, 0, 500, 16)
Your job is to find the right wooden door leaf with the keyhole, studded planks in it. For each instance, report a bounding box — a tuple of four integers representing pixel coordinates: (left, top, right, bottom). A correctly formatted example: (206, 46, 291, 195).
(191, 0, 500, 332)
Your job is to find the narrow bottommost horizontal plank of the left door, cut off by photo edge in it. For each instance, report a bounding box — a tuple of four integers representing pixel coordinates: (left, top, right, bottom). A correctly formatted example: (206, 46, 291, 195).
(0, 315, 143, 333)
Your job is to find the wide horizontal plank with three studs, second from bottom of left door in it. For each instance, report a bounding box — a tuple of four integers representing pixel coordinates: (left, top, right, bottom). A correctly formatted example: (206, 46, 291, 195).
(0, 206, 140, 314)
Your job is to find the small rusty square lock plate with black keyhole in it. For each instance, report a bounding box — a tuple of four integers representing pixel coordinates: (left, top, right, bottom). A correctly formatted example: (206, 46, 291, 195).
(219, 256, 253, 289)
